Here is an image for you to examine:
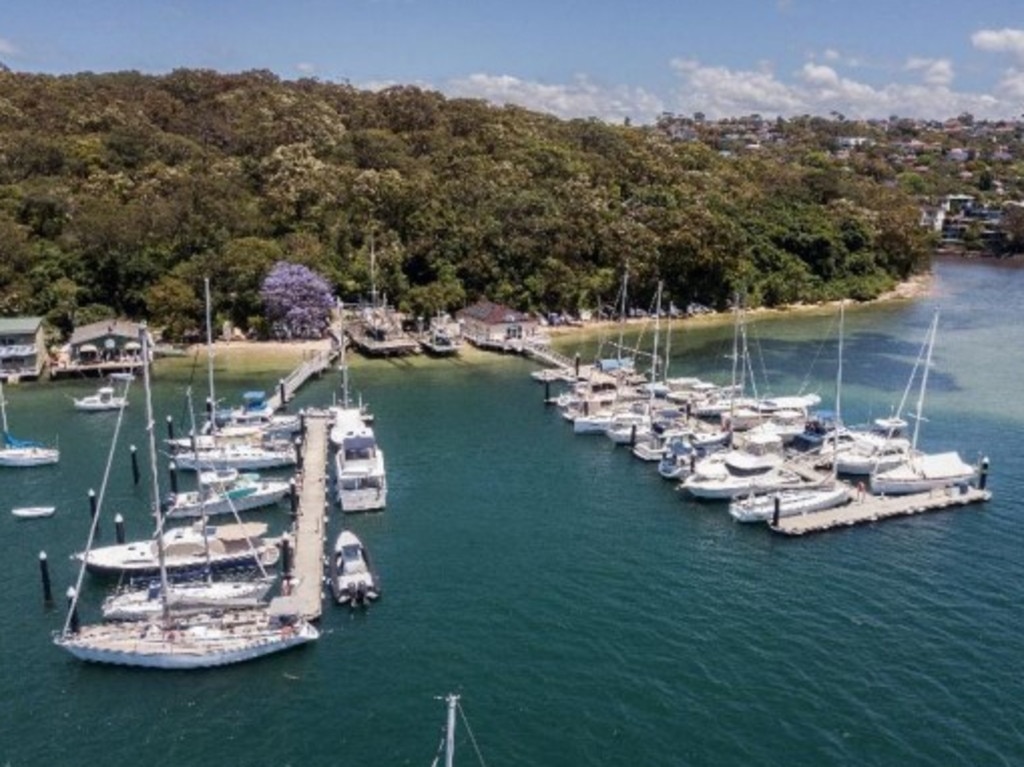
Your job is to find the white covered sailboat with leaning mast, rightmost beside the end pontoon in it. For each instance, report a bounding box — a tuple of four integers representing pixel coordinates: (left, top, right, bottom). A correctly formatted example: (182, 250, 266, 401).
(870, 311, 977, 496)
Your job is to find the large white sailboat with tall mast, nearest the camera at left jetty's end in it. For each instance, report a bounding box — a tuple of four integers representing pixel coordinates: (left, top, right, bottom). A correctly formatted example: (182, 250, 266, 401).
(53, 329, 319, 670)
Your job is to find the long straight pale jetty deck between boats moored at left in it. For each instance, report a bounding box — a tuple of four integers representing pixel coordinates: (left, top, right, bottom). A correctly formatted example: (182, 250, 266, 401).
(286, 411, 332, 621)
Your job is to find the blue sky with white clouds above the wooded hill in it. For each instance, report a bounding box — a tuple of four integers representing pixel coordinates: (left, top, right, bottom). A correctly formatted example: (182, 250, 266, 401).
(0, 0, 1024, 124)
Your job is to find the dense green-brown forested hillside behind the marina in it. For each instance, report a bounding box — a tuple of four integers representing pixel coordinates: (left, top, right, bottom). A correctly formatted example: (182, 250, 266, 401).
(0, 70, 928, 332)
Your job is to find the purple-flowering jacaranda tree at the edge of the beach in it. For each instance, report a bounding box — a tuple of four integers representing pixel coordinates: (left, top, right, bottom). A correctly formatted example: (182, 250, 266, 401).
(260, 261, 334, 338)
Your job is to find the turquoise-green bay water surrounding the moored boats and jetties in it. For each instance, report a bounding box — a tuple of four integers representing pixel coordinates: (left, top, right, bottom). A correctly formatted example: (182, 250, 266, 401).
(0, 262, 1024, 765)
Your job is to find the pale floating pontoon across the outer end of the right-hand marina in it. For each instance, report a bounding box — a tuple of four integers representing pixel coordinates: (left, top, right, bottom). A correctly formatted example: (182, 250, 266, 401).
(768, 485, 992, 536)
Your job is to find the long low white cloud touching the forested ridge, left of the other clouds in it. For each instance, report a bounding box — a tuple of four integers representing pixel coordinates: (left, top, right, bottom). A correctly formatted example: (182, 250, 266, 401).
(444, 74, 664, 123)
